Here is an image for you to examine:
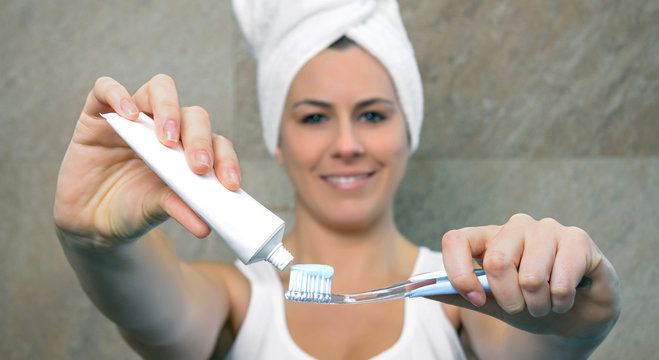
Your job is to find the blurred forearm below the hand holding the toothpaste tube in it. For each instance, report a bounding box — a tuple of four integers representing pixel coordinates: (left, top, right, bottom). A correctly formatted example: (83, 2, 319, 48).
(58, 230, 229, 359)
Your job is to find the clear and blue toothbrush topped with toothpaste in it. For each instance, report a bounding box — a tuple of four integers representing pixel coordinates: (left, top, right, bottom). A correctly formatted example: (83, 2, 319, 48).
(284, 264, 592, 304)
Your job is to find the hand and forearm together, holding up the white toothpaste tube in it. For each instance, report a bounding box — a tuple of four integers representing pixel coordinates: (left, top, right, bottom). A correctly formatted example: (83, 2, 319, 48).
(54, 75, 239, 358)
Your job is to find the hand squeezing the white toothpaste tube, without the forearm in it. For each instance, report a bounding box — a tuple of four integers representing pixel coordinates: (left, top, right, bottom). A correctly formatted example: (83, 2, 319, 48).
(54, 75, 241, 244)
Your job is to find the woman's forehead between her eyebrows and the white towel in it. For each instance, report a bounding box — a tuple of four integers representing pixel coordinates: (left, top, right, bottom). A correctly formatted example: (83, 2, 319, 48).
(288, 46, 396, 101)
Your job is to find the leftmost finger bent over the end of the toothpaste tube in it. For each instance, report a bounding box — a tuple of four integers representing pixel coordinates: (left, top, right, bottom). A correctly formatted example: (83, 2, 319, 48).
(82, 76, 138, 120)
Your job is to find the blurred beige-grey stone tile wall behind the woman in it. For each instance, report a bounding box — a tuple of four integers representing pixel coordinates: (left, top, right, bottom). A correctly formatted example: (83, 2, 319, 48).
(0, 0, 659, 359)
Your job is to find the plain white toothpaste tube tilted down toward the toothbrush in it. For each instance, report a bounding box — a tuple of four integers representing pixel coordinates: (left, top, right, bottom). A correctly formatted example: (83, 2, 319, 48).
(101, 113, 293, 271)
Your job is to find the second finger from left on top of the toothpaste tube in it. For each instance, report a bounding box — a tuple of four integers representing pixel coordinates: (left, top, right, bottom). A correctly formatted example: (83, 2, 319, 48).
(135, 74, 181, 146)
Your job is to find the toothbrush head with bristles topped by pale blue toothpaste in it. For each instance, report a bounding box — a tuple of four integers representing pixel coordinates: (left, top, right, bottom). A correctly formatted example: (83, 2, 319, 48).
(284, 264, 334, 304)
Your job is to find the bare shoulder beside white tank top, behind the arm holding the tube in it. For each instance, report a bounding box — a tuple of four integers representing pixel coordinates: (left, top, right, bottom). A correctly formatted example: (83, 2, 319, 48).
(188, 261, 251, 333)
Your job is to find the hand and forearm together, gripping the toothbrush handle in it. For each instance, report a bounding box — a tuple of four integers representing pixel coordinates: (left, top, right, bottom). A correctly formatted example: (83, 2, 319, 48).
(434, 215, 620, 359)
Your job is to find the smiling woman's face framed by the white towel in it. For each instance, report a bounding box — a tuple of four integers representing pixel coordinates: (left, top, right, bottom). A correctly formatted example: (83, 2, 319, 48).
(277, 46, 409, 230)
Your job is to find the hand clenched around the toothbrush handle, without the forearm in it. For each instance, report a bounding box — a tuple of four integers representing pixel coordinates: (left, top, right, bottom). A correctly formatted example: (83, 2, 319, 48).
(433, 214, 620, 339)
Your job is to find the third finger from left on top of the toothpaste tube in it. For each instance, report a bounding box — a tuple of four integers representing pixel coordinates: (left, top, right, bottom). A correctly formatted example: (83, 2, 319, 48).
(181, 106, 213, 174)
